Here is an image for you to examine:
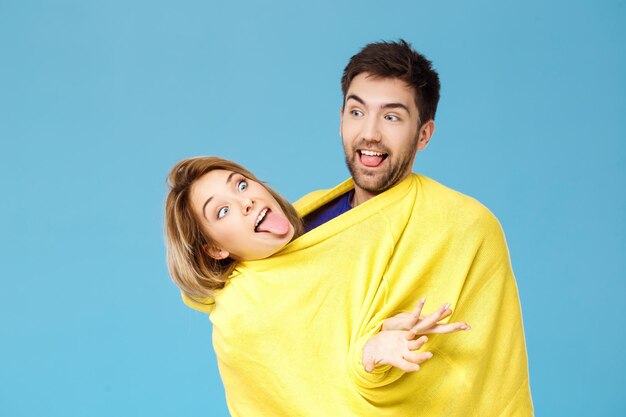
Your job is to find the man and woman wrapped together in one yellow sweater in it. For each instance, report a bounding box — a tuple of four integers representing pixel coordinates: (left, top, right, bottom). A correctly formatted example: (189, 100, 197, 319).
(166, 41, 532, 416)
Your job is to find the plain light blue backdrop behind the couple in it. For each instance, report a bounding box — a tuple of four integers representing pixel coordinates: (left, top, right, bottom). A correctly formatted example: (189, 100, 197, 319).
(0, 0, 626, 416)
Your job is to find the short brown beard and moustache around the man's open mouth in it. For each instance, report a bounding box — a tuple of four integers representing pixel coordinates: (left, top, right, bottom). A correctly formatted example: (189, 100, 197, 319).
(344, 135, 418, 194)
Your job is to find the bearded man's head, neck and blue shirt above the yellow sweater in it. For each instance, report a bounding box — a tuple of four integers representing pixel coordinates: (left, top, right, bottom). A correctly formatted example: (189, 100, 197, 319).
(305, 41, 439, 226)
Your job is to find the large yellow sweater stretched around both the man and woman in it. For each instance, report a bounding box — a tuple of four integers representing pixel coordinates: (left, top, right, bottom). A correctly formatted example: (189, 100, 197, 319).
(185, 174, 533, 417)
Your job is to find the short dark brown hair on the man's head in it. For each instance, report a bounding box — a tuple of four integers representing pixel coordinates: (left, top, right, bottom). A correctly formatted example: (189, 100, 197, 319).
(341, 39, 440, 123)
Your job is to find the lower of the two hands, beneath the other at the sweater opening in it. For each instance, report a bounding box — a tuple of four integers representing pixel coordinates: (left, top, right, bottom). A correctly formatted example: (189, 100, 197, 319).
(363, 330, 433, 372)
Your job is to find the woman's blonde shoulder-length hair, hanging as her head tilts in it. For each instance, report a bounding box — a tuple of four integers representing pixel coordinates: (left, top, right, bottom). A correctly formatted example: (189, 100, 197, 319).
(165, 157, 303, 299)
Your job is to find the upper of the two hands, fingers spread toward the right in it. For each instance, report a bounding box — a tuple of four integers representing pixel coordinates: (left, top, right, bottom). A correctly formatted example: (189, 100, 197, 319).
(382, 298, 471, 335)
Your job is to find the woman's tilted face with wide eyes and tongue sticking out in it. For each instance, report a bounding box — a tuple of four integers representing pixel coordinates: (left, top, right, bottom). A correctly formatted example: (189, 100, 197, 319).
(190, 169, 294, 261)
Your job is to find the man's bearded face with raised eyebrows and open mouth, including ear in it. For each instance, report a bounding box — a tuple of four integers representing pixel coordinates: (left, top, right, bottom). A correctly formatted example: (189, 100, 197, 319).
(341, 73, 434, 204)
